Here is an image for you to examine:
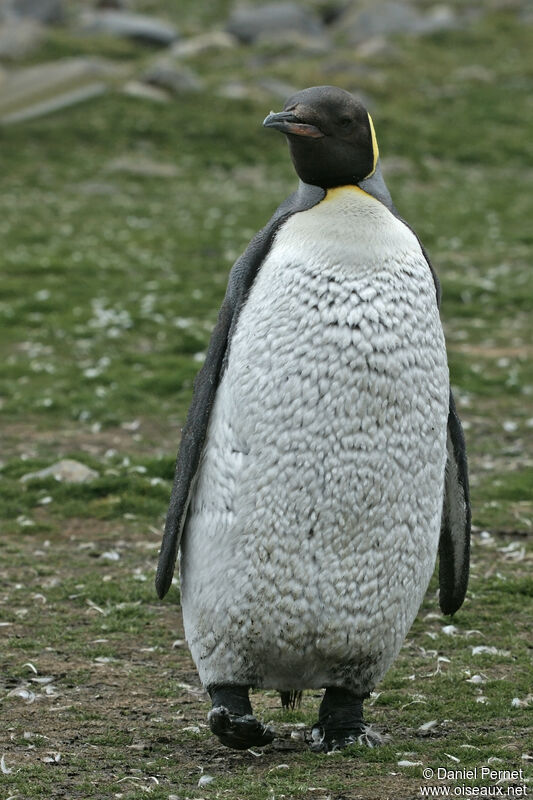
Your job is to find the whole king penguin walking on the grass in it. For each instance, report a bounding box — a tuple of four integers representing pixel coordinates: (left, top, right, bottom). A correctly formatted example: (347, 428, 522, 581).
(156, 86, 470, 752)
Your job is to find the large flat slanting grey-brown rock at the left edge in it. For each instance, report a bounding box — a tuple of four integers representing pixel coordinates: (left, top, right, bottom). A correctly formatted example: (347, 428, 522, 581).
(0, 58, 121, 123)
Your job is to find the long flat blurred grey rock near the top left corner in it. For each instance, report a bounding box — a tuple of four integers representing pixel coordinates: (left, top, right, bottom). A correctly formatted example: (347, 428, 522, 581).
(80, 10, 179, 46)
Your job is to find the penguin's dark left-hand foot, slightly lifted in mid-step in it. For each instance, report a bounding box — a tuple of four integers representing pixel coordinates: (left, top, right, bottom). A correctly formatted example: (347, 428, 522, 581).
(207, 686, 275, 750)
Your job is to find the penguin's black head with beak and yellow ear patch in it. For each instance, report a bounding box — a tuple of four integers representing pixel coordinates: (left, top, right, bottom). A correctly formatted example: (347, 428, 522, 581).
(263, 86, 378, 189)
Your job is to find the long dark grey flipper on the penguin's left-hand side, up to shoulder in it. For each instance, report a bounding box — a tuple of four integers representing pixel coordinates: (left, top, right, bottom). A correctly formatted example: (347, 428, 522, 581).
(155, 178, 326, 597)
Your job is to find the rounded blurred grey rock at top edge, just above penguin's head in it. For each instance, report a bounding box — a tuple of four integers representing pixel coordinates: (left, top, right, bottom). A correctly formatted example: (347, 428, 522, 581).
(227, 2, 323, 43)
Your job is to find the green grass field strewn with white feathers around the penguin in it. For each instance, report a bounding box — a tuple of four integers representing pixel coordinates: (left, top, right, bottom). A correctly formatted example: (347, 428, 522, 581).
(0, 6, 533, 800)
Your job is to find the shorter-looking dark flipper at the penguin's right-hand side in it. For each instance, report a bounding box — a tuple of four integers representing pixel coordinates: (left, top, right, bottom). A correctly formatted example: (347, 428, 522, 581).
(439, 391, 471, 614)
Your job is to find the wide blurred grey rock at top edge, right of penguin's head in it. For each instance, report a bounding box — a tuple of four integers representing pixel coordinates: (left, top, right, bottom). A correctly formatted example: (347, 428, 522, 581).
(336, 0, 459, 44)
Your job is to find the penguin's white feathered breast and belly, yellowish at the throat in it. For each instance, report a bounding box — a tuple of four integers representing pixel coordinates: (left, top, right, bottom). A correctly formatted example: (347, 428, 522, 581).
(181, 187, 448, 692)
